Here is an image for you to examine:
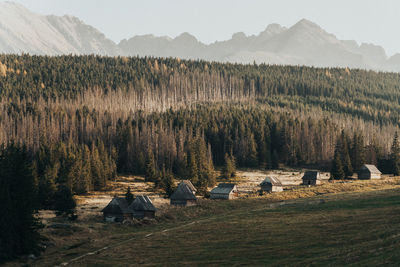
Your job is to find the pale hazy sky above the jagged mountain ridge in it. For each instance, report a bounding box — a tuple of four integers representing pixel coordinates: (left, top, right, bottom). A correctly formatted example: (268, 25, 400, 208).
(0, 0, 400, 55)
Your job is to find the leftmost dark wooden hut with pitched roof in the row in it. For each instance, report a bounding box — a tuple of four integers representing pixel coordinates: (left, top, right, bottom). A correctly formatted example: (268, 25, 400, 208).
(102, 197, 133, 222)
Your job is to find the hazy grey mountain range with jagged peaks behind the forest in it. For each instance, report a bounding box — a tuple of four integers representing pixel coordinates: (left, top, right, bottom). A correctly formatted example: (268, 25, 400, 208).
(0, 2, 400, 72)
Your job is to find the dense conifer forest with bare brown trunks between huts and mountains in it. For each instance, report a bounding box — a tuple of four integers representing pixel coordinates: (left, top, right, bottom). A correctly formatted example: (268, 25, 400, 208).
(0, 55, 400, 262)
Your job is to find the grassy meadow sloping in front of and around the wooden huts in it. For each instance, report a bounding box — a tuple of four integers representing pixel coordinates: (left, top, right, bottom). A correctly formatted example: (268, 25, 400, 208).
(10, 172, 400, 266)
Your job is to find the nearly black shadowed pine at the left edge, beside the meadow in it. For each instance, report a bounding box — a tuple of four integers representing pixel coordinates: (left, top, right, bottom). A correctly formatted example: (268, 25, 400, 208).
(0, 144, 40, 262)
